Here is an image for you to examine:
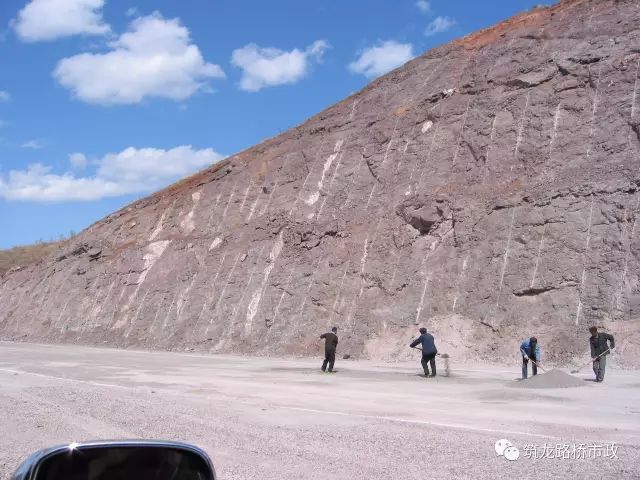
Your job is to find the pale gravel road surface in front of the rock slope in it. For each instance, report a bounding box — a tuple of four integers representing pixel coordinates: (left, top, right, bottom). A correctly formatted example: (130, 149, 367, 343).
(0, 343, 640, 480)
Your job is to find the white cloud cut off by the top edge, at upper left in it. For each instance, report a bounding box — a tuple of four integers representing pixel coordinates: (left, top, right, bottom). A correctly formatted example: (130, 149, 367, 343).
(12, 0, 109, 42)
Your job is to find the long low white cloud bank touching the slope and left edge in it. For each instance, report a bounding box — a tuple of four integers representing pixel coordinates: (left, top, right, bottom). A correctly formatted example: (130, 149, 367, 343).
(0, 145, 223, 202)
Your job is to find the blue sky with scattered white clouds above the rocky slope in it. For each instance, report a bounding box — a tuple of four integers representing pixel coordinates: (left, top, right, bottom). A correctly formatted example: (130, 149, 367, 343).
(0, 0, 552, 248)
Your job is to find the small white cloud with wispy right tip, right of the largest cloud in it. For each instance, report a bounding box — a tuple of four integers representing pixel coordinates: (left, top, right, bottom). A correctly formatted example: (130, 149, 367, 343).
(231, 40, 329, 92)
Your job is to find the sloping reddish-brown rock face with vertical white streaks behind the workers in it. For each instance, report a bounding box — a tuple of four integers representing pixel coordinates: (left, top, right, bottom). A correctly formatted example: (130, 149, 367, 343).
(0, 0, 640, 363)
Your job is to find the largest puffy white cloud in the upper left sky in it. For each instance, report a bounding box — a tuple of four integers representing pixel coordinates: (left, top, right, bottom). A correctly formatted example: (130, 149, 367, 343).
(54, 13, 225, 105)
